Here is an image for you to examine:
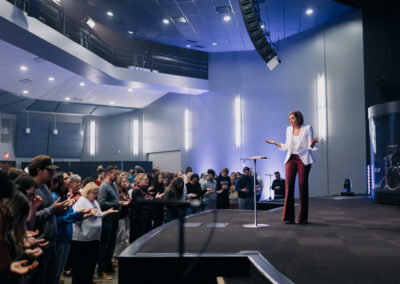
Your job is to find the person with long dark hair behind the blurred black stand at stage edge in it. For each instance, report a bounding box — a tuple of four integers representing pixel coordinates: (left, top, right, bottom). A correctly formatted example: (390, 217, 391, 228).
(164, 177, 185, 223)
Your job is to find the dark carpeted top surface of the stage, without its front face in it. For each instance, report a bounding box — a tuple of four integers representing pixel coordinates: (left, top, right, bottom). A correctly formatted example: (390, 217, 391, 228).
(123, 197, 400, 283)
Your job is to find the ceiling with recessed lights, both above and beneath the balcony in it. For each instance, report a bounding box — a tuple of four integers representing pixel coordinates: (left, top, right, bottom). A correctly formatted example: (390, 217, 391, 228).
(0, 0, 354, 115)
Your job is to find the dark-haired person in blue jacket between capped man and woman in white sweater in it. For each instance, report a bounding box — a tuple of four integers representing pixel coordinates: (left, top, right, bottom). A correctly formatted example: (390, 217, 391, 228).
(51, 172, 90, 283)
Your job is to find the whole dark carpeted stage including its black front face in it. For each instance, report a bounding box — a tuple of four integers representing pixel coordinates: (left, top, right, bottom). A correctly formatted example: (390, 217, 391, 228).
(119, 196, 400, 283)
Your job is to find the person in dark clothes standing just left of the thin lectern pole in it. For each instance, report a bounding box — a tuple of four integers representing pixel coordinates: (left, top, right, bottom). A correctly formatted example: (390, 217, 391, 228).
(235, 167, 254, 210)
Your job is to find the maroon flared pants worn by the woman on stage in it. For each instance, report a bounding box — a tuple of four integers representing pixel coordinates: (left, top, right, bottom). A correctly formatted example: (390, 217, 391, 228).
(282, 155, 311, 223)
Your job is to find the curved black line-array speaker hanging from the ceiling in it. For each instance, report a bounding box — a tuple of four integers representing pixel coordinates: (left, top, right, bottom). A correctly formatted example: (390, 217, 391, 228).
(239, 0, 281, 70)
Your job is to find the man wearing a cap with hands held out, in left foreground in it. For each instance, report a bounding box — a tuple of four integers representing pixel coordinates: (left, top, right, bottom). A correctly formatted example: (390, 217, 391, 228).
(28, 155, 72, 284)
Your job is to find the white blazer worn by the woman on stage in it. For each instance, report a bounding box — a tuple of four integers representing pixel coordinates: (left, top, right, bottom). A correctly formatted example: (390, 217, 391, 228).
(279, 125, 317, 165)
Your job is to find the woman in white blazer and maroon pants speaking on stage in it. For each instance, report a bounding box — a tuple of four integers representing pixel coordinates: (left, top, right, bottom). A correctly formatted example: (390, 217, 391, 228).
(264, 110, 319, 224)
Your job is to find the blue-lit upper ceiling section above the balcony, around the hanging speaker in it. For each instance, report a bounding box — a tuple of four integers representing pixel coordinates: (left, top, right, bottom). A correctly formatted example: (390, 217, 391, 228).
(62, 0, 354, 52)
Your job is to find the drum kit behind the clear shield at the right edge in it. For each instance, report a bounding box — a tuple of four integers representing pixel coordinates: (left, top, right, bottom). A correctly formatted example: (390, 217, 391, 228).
(384, 144, 400, 190)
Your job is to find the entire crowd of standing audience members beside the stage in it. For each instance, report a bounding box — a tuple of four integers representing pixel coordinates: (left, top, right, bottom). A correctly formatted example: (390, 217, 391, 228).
(0, 159, 276, 284)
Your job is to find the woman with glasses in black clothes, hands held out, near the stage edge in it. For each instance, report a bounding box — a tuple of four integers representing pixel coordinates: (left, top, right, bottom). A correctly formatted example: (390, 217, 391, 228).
(130, 173, 161, 243)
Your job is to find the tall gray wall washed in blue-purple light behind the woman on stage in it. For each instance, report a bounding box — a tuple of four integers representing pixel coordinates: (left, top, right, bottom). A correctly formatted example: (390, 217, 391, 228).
(143, 13, 366, 196)
